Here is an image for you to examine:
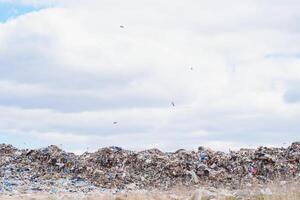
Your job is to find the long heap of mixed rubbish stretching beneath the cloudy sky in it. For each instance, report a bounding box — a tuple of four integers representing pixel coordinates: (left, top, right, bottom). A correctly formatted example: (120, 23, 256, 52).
(0, 142, 300, 193)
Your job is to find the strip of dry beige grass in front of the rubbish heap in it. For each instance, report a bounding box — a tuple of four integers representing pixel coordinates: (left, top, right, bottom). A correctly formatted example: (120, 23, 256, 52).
(0, 184, 300, 200)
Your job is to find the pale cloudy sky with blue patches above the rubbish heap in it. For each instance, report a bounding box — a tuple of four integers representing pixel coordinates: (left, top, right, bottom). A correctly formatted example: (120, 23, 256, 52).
(0, 0, 300, 152)
